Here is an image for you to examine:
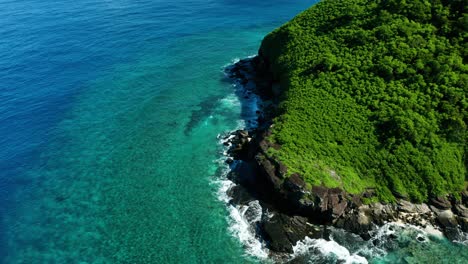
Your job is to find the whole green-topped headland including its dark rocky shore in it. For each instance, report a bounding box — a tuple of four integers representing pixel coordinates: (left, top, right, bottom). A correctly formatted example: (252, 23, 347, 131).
(225, 0, 468, 258)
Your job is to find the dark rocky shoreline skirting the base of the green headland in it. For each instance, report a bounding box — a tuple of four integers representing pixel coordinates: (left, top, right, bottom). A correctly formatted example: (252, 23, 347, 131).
(222, 56, 468, 258)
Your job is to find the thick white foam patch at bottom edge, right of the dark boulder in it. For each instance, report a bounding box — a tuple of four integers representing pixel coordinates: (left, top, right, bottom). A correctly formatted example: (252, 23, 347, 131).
(292, 237, 368, 264)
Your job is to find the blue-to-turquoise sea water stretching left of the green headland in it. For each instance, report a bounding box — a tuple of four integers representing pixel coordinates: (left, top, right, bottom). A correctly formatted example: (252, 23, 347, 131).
(0, 0, 464, 263)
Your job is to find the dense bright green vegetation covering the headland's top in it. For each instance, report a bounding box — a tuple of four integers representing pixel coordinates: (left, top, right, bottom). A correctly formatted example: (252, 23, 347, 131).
(260, 0, 468, 201)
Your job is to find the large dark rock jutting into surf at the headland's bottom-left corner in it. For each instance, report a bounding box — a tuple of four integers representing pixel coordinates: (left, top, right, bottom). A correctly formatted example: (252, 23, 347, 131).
(262, 213, 323, 253)
